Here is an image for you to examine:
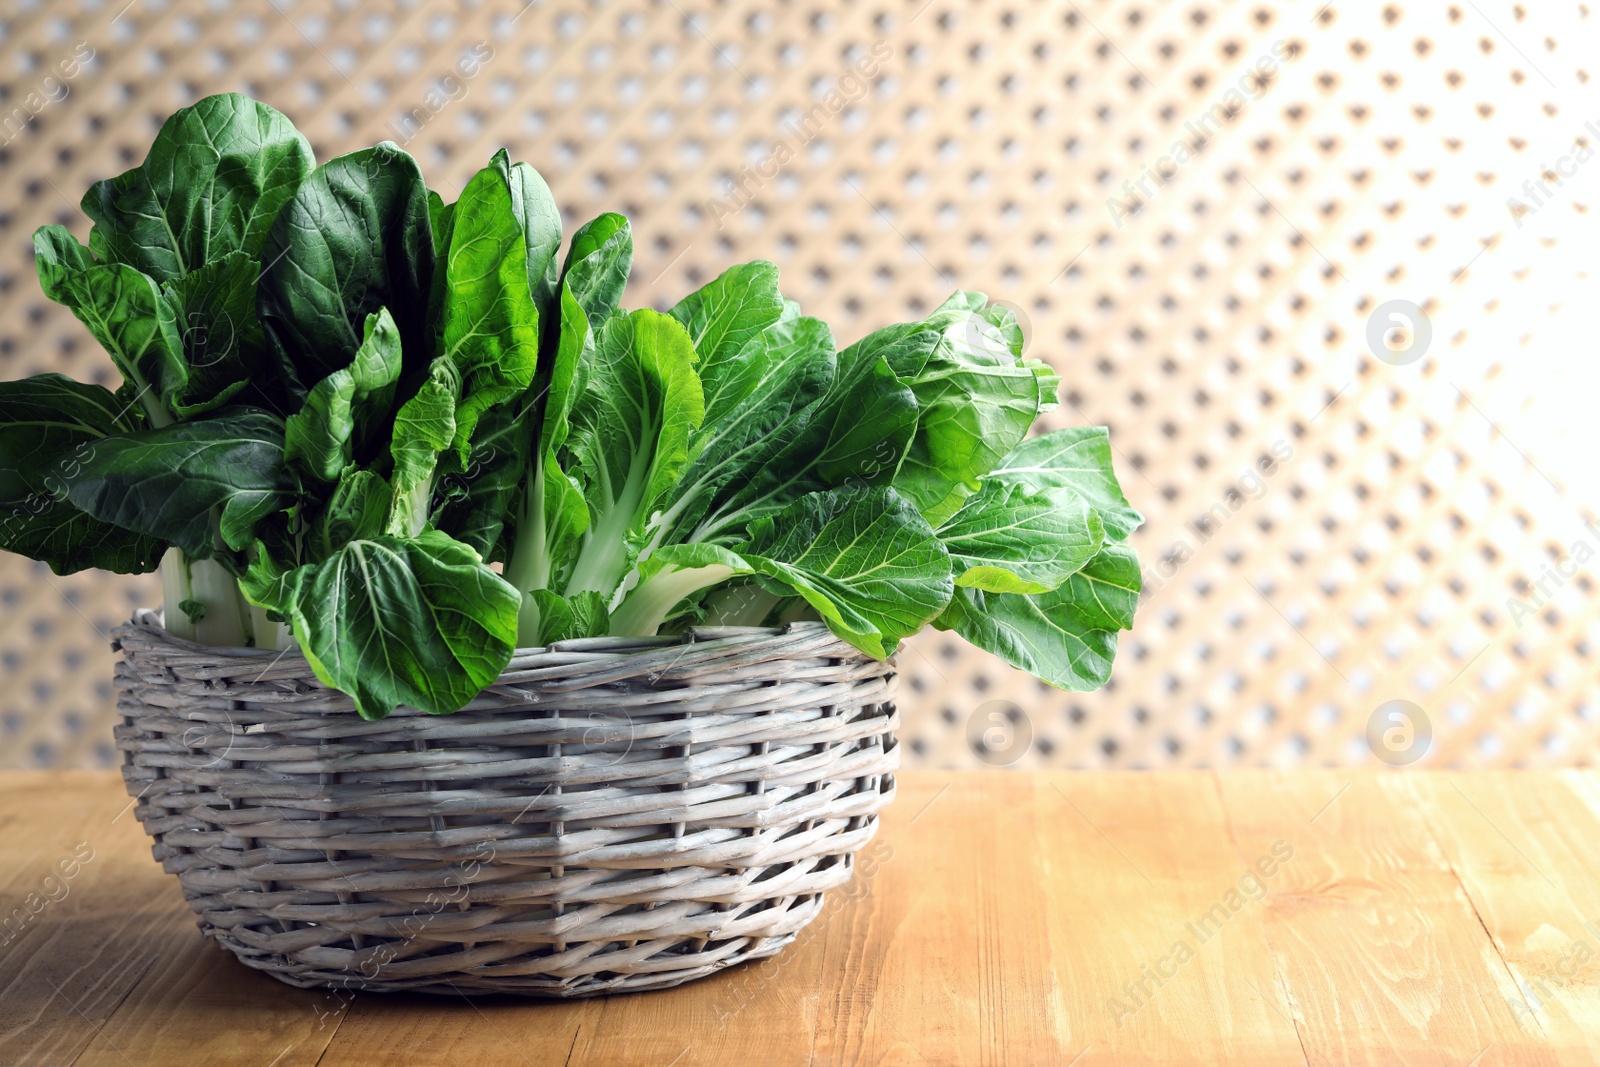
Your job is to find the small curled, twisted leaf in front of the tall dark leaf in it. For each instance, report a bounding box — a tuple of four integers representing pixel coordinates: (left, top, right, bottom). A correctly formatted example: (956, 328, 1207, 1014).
(283, 307, 402, 483)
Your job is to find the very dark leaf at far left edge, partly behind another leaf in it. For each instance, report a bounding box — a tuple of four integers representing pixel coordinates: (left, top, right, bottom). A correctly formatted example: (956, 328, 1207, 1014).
(0, 374, 166, 574)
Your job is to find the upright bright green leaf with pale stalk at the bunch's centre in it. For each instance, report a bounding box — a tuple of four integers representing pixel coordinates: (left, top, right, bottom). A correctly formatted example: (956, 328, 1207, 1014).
(566, 309, 704, 595)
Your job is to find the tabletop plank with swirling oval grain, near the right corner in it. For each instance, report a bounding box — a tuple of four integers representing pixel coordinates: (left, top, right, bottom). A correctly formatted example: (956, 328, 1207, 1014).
(1219, 771, 1554, 1065)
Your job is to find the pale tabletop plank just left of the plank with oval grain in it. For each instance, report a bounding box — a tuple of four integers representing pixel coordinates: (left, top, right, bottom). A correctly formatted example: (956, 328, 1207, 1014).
(1037, 771, 1301, 1064)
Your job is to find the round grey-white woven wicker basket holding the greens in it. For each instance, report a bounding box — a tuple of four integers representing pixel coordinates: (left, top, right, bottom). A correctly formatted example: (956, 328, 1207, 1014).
(114, 611, 899, 997)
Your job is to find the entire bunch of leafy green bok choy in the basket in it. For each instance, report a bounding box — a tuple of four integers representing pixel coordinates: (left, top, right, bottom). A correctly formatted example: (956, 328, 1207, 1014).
(0, 96, 1141, 717)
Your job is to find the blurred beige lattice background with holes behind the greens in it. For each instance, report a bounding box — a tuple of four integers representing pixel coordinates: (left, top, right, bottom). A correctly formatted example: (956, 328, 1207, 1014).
(0, 0, 1600, 768)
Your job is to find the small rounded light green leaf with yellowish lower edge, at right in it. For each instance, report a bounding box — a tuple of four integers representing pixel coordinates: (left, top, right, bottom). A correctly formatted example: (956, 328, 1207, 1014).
(939, 482, 1106, 593)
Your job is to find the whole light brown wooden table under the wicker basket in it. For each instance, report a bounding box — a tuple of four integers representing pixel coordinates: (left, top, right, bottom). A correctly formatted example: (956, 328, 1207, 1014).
(0, 771, 1600, 1067)
